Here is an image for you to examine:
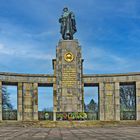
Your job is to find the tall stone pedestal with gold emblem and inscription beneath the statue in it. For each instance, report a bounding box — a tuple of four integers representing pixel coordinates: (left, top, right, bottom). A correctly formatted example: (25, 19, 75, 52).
(54, 40, 83, 112)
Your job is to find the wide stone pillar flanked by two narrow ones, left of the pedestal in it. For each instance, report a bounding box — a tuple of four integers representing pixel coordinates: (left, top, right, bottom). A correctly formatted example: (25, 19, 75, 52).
(23, 83, 33, 121)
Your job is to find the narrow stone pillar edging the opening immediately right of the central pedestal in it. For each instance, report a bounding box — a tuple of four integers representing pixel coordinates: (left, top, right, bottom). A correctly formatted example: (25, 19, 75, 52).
(99, 83, 105, 121)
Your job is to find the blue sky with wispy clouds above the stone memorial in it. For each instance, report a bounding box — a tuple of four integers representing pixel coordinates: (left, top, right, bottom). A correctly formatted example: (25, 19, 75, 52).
(0, 0, 140, 110)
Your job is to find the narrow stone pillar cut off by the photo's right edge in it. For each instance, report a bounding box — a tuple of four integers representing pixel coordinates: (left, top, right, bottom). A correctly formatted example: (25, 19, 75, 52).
(136, 81, 140, 120)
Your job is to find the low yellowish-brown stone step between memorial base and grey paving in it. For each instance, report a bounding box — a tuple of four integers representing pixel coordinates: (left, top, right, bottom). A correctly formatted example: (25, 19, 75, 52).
(0, 121, 140, 128)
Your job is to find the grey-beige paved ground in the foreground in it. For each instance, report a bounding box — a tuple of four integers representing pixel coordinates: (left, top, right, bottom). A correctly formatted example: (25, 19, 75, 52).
(0, 127, 140, 140)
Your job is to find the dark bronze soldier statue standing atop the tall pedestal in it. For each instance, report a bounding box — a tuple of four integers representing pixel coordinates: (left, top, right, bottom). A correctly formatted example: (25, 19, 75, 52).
(59, 7, 77, 40)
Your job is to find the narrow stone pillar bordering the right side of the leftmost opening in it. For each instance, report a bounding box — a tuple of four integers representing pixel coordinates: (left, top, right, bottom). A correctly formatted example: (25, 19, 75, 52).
(17, 83, 23, 121)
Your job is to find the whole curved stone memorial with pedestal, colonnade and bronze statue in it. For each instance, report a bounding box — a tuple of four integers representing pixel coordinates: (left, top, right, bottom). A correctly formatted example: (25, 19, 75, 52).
(0, 7, 140, 121)
